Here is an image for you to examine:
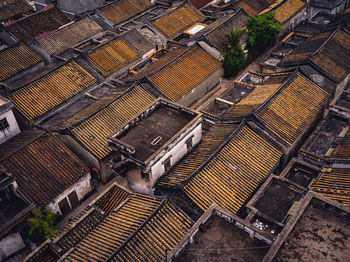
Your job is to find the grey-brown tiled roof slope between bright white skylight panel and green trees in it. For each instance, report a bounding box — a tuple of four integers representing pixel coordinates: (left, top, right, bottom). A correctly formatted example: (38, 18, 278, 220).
(205, 9, 248, 50)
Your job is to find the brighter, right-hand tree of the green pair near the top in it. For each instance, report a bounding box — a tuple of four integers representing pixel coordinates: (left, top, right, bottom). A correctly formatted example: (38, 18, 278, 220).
(247, 12, 283, 55)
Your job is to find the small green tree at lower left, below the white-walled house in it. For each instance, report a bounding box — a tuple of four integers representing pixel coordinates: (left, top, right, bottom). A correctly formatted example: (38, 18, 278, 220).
(28, 206, 58, 239)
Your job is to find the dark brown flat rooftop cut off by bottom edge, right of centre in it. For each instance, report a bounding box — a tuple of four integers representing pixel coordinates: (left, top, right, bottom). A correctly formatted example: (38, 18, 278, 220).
(175, 216, 269, 262)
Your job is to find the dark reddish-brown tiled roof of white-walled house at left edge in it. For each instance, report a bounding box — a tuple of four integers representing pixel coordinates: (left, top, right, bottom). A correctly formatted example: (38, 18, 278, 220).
(0, 133, 89, 207)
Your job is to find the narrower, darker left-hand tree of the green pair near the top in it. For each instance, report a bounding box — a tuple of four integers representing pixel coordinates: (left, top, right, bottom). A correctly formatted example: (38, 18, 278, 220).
(223, 28, 246, 78)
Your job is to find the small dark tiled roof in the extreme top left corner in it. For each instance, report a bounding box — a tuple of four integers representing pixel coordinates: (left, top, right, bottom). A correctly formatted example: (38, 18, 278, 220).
(0, 0, 34, 22)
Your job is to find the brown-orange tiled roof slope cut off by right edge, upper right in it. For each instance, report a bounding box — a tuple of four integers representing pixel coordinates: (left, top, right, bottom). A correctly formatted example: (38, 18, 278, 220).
(311, 30, 350, 82)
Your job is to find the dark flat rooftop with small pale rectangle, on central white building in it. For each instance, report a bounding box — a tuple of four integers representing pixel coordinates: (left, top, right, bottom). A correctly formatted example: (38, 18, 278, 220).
(117, 105, 196, 161)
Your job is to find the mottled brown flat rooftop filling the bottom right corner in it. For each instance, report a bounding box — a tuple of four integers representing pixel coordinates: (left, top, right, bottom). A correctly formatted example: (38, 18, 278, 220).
(274, 206, 350, 262)
